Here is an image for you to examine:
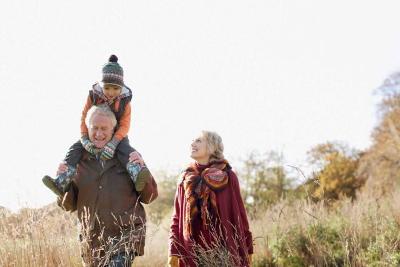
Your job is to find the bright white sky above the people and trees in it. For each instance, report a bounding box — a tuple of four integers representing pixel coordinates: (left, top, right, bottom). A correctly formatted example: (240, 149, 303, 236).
(0, 0, 400, 213)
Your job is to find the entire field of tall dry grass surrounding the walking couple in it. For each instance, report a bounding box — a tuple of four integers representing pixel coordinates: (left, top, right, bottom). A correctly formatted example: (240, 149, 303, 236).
(0, 188, 400, 267)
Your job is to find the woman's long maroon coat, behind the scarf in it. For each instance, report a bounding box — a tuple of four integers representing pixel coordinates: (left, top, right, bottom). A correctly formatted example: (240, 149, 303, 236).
(169, 166, 253, 266)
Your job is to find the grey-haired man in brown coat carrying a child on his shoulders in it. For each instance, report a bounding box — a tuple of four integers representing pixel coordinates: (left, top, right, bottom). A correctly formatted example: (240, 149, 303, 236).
(58, 105, 158, 267)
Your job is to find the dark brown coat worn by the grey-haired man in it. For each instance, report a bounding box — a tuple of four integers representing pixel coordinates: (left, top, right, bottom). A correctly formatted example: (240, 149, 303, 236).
(59, 152, 158, 266)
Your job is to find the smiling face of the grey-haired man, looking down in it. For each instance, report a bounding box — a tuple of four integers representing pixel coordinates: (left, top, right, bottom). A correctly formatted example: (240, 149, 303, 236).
(89, 114, 114, 148)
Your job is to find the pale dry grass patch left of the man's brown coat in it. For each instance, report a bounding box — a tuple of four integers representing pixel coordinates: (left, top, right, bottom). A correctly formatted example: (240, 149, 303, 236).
(0, 205, 81, 267)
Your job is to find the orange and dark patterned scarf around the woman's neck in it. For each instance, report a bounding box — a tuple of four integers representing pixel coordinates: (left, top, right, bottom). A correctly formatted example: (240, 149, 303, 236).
(183, 160, 231, 239)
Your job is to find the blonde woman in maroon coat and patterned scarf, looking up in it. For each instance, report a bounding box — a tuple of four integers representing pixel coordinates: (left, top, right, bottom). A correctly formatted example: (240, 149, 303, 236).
(168, 131, 253, 267)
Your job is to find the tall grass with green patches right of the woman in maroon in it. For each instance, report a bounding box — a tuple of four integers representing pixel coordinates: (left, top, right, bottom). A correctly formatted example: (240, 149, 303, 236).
(252, 191, 400, 266)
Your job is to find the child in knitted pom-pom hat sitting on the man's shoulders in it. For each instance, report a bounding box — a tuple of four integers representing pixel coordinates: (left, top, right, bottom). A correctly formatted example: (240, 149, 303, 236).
(42, 55, 151, 195)
